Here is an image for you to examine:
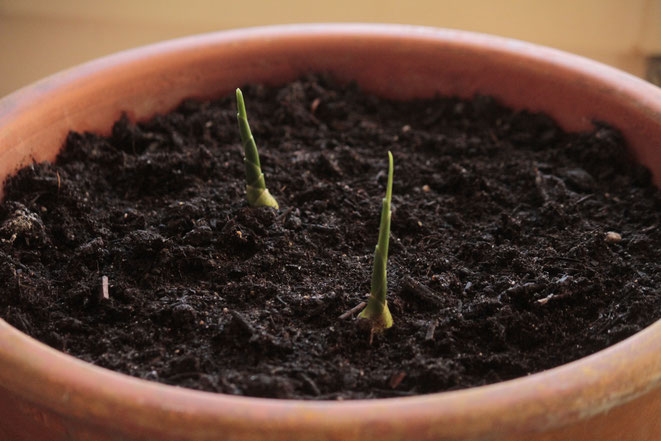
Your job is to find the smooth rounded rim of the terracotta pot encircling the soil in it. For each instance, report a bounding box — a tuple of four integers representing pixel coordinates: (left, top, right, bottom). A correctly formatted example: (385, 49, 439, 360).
(0, 24, 661, 435)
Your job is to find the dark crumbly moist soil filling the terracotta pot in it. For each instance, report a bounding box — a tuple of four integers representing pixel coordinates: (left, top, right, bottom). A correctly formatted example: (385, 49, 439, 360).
(0, 76, 661, 399)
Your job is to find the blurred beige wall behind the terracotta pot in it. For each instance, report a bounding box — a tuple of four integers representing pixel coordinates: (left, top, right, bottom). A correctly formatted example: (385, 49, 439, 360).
(0, 0, 661, 96)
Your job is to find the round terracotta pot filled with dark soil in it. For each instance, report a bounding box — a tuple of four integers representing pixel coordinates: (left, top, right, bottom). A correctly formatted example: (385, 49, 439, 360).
(0, 25, 661, 441)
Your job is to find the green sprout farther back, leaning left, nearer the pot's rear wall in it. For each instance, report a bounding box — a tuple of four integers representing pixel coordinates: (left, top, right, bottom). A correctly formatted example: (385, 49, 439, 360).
(236, 89, 278, 209)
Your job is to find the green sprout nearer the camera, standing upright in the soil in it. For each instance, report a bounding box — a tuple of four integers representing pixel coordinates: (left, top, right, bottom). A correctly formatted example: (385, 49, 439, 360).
(358, 152, 393, 341)
